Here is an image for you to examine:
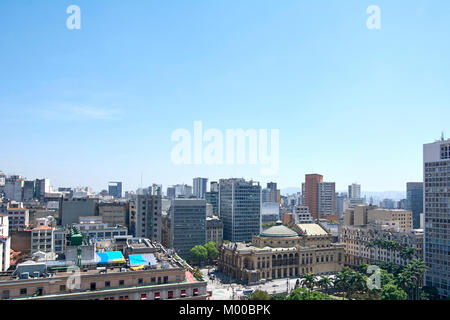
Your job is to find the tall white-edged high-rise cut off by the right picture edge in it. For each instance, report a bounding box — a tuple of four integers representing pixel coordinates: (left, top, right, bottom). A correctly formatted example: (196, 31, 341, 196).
(423, 138, 450, 297)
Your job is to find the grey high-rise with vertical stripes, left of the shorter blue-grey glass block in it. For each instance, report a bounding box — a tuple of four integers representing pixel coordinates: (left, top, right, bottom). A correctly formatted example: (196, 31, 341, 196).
(135, 193, 162, 242)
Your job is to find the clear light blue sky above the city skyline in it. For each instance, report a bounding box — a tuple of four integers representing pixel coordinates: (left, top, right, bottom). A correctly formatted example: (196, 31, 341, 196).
(0, 0, 450, 191)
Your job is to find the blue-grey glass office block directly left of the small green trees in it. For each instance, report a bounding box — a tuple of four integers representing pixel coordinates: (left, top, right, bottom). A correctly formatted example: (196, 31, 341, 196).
(170, 199, 206, 259)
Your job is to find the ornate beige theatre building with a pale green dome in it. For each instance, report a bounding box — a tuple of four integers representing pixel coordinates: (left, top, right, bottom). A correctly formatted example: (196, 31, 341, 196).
(218, 221, 344, 284)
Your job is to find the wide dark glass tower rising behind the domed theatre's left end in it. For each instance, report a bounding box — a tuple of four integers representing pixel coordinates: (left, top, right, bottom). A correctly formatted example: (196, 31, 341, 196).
(219, 179, 261, 242)
